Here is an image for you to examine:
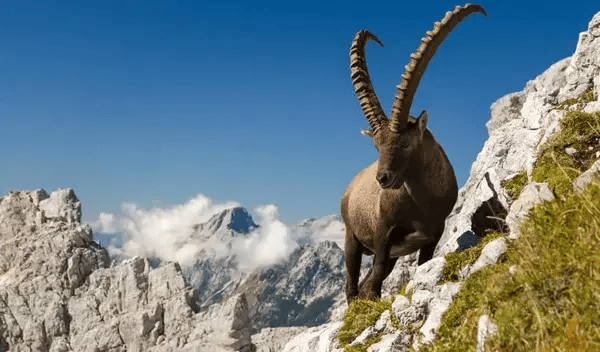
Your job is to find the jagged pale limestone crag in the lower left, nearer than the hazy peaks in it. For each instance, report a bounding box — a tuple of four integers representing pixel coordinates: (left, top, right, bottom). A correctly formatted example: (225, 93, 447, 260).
(0, 189, 254, 352)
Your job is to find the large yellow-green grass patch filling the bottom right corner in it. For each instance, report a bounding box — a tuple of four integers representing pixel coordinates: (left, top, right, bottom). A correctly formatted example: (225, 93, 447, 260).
(422, 179, 600, 351)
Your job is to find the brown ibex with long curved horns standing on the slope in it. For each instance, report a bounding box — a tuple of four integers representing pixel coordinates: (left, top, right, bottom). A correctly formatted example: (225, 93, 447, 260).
(341, 4, 487, 302)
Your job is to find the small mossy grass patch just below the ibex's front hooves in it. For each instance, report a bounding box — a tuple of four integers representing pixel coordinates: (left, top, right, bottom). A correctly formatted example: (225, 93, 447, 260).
(338, 298, 398, 352)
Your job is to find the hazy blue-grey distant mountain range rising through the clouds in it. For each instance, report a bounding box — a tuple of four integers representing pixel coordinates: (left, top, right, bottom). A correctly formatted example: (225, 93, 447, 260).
(183, 207, 344, 329)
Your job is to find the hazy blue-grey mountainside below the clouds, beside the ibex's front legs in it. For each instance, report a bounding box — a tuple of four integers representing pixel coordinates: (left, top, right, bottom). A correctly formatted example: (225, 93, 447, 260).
(229, 241, 345, 329)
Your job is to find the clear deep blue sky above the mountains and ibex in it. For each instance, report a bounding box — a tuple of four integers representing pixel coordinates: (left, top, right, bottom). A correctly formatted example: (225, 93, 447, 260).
(0, 0, 600, 222)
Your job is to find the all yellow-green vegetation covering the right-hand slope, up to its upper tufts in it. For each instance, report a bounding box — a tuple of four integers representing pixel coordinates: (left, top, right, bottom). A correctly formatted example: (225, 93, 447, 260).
(421, 95, 600, 351)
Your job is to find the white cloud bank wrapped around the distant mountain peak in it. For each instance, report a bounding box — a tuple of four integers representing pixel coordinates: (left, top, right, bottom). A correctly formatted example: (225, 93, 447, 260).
(91, 194, 344, 270)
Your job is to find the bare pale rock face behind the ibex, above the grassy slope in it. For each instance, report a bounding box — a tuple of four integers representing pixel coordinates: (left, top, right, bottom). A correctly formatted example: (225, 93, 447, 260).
(435, 13, 600, 256)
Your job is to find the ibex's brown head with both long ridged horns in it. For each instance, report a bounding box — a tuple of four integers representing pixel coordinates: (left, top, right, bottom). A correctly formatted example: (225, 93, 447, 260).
(350, 4, 487, 188)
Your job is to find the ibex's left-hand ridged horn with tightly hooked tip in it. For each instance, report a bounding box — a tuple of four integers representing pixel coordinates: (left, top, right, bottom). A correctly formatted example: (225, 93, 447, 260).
(350, 30, 387, 133)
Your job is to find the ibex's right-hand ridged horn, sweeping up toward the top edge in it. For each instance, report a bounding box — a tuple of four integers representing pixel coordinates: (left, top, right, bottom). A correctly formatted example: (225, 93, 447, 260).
(389, 4, 487, 132)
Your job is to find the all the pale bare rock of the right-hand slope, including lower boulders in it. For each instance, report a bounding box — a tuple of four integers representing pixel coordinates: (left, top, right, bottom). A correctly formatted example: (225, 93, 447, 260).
(278, 9, 600, 352)
